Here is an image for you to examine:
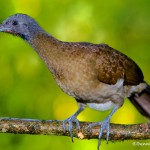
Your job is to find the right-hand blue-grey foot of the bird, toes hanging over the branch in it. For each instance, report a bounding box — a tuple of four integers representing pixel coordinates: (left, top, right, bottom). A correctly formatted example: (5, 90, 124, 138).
(88, 117, 110, 150)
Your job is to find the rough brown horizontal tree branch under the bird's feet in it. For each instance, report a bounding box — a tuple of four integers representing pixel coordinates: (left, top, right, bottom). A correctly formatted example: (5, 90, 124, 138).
(0, 118, 150, 141)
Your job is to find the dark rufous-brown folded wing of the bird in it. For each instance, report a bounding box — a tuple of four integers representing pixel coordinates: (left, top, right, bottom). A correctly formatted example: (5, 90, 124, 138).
(96, 44, 144, 85)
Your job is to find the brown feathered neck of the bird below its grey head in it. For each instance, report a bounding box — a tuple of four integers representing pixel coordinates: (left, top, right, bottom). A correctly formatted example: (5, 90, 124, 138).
(28, 32, 61, 72)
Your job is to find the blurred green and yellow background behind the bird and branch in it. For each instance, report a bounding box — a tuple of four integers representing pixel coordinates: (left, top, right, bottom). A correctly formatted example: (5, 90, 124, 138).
(0, 0, 150, 150)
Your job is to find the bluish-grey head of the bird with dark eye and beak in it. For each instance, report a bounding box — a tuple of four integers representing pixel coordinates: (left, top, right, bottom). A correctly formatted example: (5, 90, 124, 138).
(0, 14, 43, 41)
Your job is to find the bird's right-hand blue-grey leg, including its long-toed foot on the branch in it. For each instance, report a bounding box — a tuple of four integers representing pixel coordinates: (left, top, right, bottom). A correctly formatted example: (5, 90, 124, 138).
(89, 106, 119, 150)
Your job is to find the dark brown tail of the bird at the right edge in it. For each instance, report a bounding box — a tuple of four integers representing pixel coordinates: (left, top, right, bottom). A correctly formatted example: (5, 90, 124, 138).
(129, 85, 150, 120)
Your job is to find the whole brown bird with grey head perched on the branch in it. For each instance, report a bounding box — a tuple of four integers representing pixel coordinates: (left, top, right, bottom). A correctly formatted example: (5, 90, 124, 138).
(0, 13, 150, 149)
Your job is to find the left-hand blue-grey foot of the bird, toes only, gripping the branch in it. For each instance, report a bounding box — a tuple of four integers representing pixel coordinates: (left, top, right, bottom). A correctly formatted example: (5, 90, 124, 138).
(63, 115, 80, 142)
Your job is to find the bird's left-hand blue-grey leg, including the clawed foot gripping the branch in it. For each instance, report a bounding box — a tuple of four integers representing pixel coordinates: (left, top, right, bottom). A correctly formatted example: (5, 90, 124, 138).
(63, 103, 85, 142)
